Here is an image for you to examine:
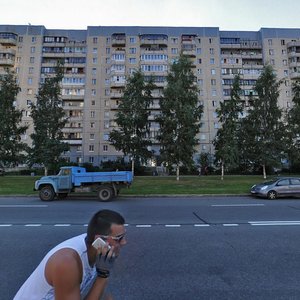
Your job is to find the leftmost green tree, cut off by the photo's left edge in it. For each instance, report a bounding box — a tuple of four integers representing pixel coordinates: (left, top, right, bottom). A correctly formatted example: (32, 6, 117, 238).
(0, 69, 27, 167)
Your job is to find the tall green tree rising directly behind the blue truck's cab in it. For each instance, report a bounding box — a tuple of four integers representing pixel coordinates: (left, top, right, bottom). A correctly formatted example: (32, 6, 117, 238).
(29, 63, 69, 175)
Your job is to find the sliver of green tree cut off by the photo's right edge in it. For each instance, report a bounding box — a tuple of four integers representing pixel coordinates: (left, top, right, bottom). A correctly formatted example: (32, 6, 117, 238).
(286, 80, 300, 168)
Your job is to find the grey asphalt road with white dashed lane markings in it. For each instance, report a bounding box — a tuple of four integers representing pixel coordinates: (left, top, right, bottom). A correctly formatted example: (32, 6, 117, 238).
(0, 197, 300, 300)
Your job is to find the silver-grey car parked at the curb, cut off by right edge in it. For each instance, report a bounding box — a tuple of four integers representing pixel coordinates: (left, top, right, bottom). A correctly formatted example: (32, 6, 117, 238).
(250, 177, 300, 199)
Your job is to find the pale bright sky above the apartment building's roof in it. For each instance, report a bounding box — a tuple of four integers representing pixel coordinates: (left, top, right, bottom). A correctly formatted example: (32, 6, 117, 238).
(0, 0, 300, 31)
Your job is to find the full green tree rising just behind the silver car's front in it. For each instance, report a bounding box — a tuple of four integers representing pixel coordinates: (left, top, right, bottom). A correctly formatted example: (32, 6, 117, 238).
(240, 65, 284, 178)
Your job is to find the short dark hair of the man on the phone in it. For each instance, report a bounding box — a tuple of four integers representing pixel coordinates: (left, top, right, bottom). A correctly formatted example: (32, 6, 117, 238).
(86, 209, 125, 244)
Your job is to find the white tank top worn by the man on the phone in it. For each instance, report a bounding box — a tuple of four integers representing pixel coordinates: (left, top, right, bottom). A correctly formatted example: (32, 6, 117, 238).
(14, 234, 96, 300)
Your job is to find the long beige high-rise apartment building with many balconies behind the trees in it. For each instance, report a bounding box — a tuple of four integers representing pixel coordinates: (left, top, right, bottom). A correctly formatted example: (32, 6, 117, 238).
(0, 25, 300, 165)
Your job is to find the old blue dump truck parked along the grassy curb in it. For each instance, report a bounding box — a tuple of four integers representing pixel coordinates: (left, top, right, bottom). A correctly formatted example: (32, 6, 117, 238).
(34, 167, 132, 201)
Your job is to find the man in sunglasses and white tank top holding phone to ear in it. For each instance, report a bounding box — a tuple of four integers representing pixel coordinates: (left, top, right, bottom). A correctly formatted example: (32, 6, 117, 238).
(14, 210, 126, 300)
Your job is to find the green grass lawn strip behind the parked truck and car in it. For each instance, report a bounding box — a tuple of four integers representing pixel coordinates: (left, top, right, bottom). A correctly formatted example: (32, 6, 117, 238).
(0, 175, 273, 195)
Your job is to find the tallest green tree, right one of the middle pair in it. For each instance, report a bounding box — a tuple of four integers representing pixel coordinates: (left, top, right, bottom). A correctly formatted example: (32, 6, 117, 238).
(156, 55, 202, 180)
